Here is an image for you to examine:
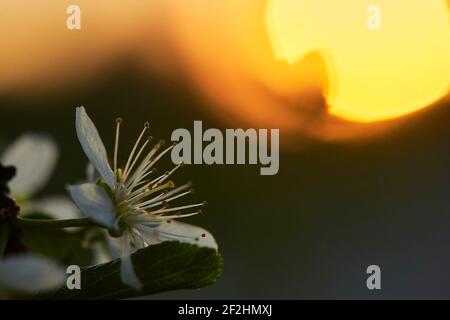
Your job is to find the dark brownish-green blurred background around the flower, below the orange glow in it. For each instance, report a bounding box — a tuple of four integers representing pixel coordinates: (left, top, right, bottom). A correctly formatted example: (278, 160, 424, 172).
(0, 67, 450, 299)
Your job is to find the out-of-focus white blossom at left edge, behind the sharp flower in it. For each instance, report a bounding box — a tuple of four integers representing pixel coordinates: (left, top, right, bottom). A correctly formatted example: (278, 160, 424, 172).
(0, 133, 80, 219)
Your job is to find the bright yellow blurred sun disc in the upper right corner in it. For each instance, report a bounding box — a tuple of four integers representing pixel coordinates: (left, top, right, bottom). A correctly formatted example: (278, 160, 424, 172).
(266, 0, 450, 122)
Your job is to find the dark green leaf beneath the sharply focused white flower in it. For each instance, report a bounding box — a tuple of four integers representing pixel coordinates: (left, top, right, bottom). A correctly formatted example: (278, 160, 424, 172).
(38, 242, 222, 299)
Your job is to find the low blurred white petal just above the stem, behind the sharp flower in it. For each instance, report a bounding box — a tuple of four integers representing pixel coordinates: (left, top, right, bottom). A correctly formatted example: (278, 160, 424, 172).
(21, 196, 83, 219)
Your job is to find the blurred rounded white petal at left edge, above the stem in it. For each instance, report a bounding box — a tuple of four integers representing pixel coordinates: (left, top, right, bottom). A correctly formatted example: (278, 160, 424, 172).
(1, 133, 58, 198)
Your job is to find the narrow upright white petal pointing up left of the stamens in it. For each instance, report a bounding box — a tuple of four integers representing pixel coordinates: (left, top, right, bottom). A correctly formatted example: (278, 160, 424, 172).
(75, 107, 116, 187)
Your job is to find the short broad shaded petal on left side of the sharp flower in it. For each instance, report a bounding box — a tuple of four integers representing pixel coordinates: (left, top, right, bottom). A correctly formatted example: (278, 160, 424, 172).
(67, 183, 117, 228)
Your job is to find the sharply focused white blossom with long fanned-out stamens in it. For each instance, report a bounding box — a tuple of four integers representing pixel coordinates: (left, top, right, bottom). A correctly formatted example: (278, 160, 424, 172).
(67, 107, 217, 289)
